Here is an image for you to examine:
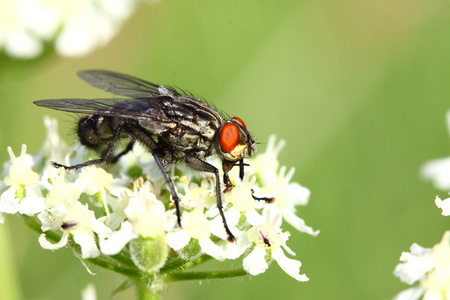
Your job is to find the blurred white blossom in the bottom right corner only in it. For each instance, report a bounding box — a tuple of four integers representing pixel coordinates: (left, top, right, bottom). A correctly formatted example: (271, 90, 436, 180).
(394, 231, 450, 300)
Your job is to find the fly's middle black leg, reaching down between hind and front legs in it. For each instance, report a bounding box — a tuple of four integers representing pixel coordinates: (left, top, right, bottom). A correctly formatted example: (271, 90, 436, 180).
(126, 125, 181, 227)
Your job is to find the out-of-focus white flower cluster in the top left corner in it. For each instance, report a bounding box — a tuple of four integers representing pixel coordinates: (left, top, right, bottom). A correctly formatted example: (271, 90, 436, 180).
(0, 0, 143, 58)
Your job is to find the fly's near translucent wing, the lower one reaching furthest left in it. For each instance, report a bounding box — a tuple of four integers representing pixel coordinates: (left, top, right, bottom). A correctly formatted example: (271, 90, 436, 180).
(33, 98, 172, 122)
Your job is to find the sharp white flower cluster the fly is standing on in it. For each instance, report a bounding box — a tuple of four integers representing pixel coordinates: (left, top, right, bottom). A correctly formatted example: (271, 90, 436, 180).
(0, 118, 319, 281)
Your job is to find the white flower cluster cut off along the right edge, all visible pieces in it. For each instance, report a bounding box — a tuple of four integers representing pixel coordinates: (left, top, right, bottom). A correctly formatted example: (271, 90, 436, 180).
(394, 111, 450, 300)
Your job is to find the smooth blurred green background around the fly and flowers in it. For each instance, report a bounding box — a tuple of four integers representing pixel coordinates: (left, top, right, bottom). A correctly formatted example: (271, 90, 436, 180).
(0, 0, 450, 300)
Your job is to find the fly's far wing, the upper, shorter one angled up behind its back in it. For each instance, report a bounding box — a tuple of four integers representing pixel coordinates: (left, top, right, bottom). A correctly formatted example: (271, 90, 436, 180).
(77, 70, 175, 98)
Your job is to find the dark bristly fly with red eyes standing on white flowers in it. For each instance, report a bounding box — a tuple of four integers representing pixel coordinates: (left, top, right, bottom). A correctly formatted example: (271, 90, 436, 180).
(34, 70, 256, 241)
